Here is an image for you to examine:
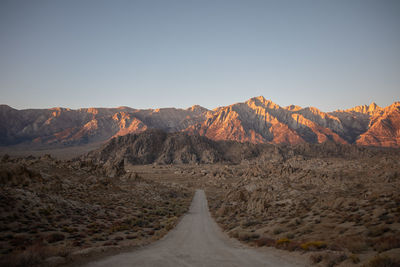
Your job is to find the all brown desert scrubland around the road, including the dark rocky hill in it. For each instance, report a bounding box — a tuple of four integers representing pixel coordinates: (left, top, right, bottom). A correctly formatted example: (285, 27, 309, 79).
(0, 131, 400, 266)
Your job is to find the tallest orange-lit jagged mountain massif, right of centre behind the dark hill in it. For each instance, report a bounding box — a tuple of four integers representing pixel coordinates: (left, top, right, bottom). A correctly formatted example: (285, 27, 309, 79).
(192, 97, 347, 147)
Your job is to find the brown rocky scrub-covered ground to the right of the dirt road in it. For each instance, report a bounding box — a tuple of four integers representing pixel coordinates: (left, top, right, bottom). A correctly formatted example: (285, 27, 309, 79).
(203, 147, 400, 266)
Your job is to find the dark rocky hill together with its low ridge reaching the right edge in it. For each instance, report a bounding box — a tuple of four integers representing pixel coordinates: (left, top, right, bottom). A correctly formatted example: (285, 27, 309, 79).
(79, 130, 400, 170)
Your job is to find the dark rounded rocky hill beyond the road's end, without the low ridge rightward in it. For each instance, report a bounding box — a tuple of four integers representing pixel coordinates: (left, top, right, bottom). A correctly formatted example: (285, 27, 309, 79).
(81, 130, 273, 166)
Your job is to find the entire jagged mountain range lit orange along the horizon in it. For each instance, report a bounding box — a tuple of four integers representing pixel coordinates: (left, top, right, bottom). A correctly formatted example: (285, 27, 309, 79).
(0, 96, 400, 148)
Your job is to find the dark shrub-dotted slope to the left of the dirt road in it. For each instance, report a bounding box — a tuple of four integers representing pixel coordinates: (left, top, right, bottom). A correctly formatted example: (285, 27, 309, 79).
(0, 156, 193, 266)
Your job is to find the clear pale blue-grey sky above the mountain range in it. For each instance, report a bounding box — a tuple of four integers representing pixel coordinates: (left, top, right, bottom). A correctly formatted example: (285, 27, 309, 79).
(0, 0, 400, 111)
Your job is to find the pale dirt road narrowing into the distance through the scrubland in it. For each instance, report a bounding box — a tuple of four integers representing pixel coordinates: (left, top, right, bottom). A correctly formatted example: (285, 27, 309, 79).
(87, 190, 305, 267)
